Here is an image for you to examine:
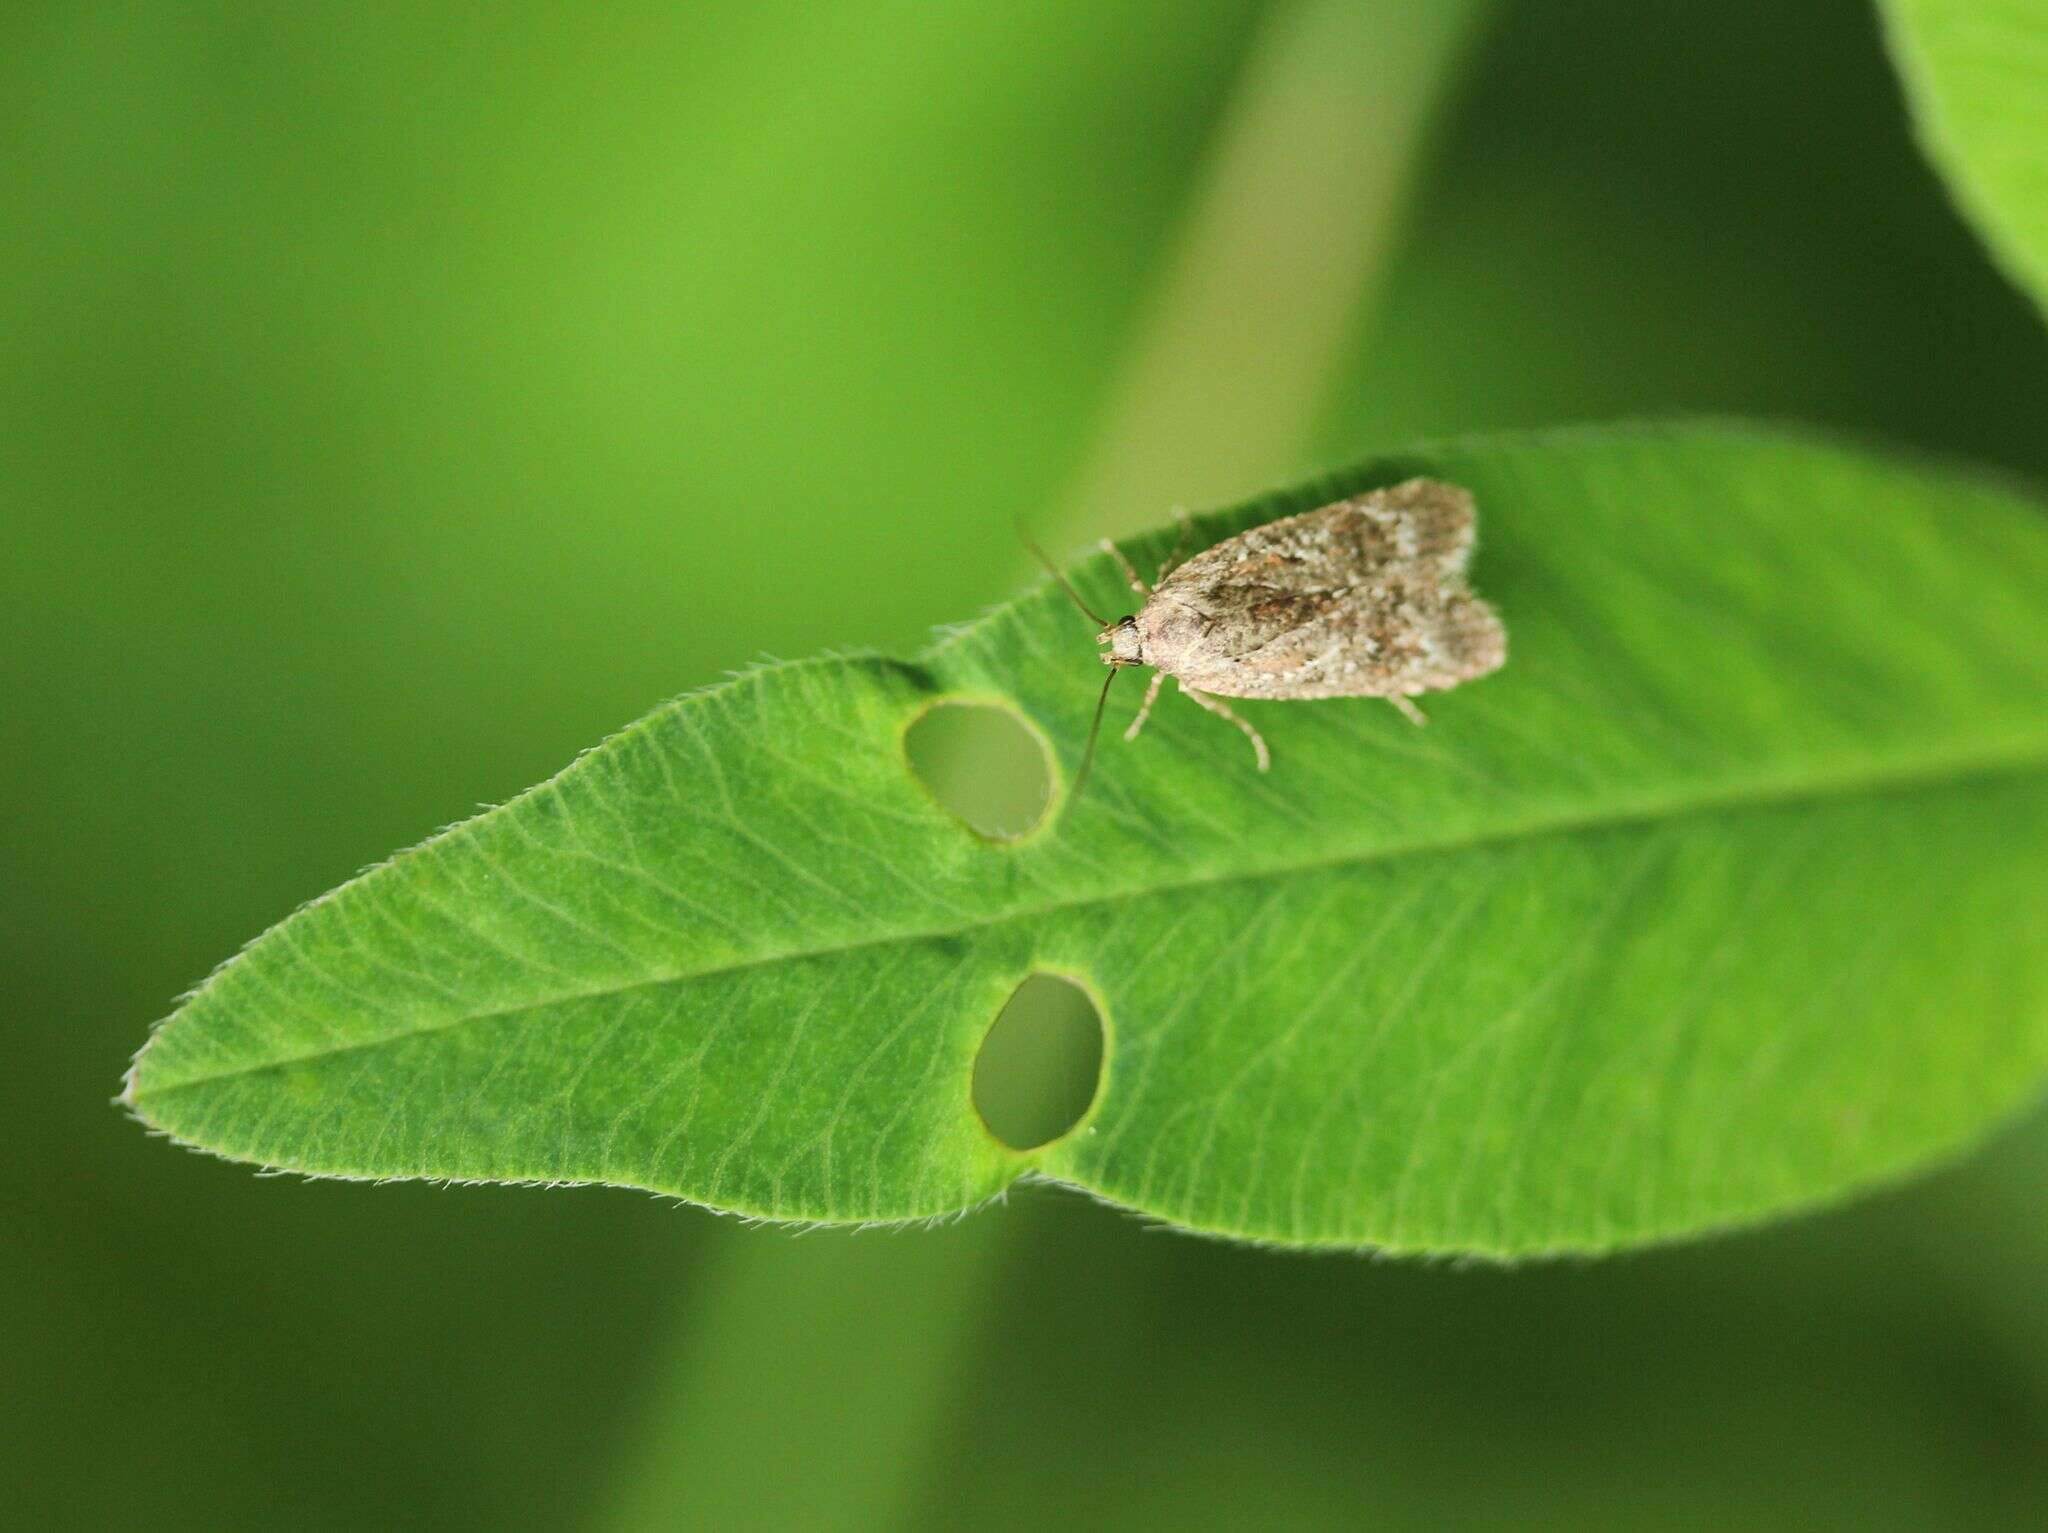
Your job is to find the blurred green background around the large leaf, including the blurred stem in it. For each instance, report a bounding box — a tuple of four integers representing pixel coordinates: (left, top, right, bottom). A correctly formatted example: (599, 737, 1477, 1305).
(0, 0, 2048, 1529)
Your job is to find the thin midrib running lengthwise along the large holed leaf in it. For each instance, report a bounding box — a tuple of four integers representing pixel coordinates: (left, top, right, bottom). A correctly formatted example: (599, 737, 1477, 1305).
(121, 741, 2048, 1107)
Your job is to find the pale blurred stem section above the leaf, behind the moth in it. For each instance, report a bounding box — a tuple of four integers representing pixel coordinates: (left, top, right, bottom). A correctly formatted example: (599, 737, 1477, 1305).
(1071, 0, 1487, 534)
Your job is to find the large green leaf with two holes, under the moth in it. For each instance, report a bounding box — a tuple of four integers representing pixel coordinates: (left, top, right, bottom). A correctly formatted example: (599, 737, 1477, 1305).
(127, 426, 2048, 1255)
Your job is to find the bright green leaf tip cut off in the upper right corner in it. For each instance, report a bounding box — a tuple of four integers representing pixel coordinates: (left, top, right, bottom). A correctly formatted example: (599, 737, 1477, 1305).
(1882, 0, 2048, 309)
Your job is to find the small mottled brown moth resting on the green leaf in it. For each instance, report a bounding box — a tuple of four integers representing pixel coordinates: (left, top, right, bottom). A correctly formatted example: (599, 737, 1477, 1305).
(1038, 479, 1507, 802)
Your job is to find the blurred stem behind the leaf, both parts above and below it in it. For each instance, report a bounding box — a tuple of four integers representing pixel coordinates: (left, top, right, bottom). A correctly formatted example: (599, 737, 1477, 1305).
(604, 0, 1485, 1529)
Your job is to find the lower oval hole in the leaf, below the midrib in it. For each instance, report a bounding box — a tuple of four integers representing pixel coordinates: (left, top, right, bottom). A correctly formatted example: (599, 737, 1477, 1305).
(975, 974, 1102, 1150)
